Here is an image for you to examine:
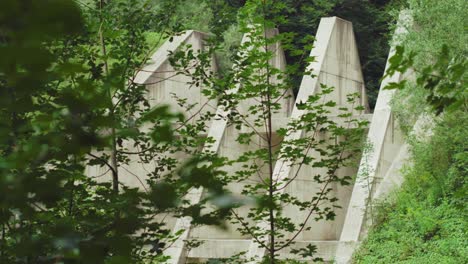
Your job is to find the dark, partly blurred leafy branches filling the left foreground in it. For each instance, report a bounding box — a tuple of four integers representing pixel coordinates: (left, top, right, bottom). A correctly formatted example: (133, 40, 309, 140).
(0, 0, 234, 263)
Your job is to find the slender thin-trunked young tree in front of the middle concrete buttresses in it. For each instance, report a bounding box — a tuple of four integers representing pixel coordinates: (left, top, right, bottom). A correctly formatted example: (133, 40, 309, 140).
(170, 1, 372, 263)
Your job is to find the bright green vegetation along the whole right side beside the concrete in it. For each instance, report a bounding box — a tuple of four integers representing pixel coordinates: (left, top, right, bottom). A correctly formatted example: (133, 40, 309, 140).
(354, 0, 468, 263)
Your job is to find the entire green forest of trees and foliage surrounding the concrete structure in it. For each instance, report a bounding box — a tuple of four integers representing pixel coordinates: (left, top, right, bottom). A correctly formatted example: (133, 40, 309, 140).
(0, 0, 468, 264)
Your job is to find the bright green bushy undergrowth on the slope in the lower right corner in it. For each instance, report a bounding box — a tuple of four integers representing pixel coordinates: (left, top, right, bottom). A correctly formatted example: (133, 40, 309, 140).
(354, 112, 468, 263)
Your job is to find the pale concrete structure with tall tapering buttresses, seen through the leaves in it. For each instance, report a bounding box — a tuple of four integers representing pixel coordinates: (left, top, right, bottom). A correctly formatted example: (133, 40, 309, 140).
(87, 13, 418, 264)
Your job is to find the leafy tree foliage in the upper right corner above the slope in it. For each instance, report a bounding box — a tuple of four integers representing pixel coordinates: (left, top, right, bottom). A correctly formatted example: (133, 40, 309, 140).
(387, 0, 468, 114)
